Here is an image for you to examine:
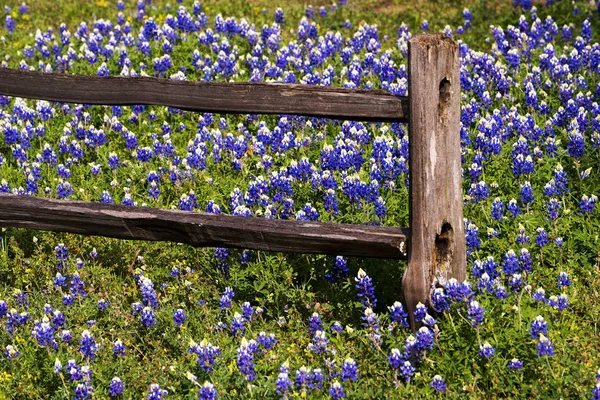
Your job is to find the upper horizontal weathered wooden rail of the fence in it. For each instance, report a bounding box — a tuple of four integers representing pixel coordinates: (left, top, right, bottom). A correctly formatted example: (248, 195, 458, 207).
(0, 68, 408, 122)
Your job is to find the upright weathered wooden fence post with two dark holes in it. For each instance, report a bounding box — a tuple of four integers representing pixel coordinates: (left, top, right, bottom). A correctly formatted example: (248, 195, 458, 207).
(402, 34, 466, 330)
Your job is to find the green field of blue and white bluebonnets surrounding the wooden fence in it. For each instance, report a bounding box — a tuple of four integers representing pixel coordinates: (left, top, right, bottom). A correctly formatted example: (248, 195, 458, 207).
(0, 0, 600, 399)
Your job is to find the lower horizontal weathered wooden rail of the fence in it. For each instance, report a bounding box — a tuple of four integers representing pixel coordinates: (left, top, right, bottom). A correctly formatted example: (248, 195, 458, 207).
(0, 194, 409, 259)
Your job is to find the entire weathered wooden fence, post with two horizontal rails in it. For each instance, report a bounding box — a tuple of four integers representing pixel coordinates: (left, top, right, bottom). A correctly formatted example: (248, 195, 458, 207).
(0, 34, 466, 329)
